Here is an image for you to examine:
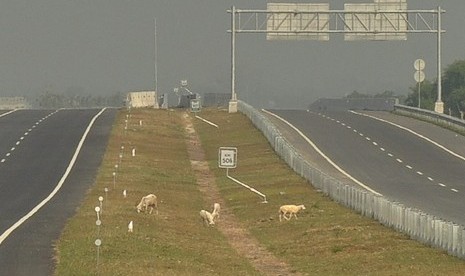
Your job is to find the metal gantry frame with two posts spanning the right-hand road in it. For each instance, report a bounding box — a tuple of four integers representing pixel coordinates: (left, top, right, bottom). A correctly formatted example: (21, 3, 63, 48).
(227, 6, 445, 113)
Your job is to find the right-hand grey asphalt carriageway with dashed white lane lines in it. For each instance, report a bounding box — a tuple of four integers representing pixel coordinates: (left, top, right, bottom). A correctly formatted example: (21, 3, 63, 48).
(264, 110, 465, 225)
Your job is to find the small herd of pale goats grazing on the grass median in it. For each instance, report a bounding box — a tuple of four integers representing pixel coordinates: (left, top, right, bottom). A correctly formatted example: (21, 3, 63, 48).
(136, 194, 305, 226)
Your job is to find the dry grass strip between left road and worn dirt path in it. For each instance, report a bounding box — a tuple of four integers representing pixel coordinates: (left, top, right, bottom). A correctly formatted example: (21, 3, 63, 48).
(55, 109, 257, 275)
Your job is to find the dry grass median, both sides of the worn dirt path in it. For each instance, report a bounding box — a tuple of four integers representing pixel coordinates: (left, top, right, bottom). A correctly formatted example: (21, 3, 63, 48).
(55, 106, 465, 275)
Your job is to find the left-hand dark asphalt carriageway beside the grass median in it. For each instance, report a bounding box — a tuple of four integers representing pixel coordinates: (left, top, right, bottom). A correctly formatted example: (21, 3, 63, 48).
(0, 109, 117, 275)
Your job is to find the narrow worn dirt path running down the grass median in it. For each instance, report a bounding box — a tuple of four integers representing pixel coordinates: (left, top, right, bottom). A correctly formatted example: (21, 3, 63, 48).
(183, 114, 301, 275)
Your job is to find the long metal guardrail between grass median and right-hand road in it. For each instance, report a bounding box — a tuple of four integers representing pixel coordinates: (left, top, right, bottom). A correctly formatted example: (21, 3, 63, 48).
(238, 101, 465, 258)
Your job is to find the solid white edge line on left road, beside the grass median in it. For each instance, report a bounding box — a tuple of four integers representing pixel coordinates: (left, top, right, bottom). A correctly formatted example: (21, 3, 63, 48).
(0, 108, 106, 245)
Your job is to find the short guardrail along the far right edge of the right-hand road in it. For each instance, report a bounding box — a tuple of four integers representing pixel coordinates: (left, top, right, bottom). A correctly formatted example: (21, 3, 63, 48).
(394, 104, 465, 132)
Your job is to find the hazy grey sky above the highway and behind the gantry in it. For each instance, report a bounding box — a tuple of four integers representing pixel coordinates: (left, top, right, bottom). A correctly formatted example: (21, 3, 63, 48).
(0, 0, 465, 108)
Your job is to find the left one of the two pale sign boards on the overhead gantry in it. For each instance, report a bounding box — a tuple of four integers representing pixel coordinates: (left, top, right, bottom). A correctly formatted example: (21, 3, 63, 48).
(266, 3, 329, 41)
